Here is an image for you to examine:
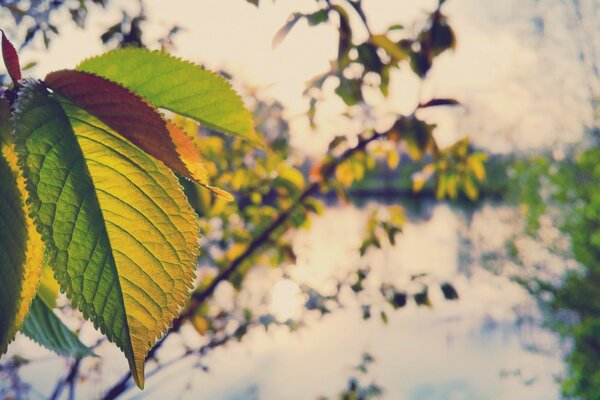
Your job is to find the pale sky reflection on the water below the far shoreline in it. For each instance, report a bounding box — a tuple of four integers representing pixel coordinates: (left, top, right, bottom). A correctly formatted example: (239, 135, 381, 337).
(7, 204, 563, 399)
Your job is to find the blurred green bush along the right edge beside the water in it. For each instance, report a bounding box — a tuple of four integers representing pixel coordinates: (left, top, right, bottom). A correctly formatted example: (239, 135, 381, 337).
(514, 147, 600, 399)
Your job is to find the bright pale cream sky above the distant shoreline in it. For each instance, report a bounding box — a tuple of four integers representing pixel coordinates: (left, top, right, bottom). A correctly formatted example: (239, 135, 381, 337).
(19, 0, 591, 155)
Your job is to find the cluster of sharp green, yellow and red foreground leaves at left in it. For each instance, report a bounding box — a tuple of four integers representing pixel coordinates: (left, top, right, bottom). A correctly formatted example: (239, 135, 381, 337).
(0, 32, 254, 387)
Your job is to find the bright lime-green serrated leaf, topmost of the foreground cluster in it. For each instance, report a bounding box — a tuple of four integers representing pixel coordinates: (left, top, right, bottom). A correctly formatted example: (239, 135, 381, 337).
(77, 48, 264, 146)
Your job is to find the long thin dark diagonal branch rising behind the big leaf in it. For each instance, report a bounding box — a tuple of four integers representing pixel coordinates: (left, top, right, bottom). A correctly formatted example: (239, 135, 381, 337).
(103, 127, 389, 400)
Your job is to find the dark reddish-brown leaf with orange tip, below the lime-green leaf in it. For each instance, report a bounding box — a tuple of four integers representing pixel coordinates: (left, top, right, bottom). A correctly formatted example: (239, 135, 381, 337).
(44, 70, 208, 185)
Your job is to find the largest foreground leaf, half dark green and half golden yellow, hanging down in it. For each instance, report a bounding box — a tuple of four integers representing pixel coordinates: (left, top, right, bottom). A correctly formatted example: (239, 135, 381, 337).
(15, 81, 198, 387)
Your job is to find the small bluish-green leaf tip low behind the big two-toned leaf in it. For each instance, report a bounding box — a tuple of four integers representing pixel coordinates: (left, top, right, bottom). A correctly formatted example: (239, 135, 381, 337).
(21, 296, 94, 358)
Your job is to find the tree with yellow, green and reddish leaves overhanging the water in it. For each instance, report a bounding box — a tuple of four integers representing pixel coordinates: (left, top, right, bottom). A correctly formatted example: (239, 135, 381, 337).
(3, 1, 486, 398)
